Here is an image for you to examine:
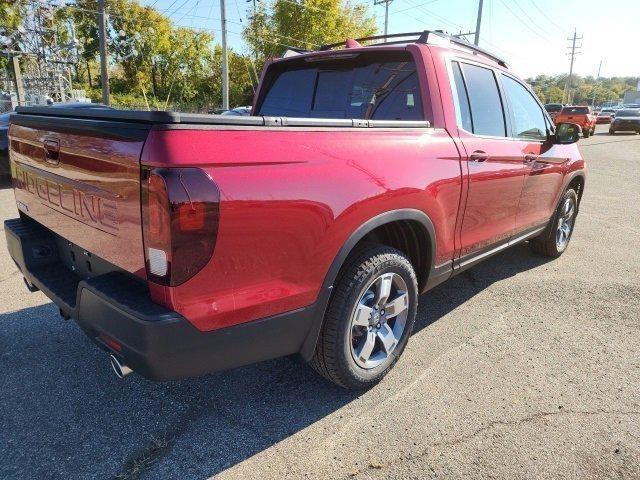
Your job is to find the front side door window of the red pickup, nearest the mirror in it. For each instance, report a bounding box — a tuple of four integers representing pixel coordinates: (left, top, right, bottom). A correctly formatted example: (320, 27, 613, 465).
(502, 75, 547, 140)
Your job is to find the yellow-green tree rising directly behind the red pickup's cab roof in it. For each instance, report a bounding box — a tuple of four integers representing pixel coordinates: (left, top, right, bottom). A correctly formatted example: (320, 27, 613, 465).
(243, 0, 376, 59)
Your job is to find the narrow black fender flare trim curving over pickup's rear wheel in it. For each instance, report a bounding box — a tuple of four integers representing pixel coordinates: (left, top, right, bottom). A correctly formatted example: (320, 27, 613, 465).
(300, 208, 436, 361)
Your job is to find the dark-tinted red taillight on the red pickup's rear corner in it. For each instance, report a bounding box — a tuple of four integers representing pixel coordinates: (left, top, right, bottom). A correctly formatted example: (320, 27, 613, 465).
(142, 168, 220, 286)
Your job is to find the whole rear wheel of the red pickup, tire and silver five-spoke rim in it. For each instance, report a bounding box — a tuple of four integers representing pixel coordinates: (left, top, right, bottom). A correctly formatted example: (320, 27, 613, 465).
(311, 245, 418, 389)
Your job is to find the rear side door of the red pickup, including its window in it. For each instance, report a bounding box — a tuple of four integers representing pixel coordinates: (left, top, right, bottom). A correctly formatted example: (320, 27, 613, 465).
(451, 61, 524, 266)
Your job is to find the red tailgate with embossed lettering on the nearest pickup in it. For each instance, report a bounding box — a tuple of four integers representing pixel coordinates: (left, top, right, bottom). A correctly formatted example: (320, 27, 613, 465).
(9, 115, 151, 277)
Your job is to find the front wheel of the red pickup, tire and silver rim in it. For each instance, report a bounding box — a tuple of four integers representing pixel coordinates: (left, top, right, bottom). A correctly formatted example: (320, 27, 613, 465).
(529, 188, 578, 258)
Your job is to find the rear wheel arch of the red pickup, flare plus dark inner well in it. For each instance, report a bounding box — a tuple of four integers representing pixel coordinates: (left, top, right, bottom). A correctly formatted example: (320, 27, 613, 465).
(300, 208, 436, 360)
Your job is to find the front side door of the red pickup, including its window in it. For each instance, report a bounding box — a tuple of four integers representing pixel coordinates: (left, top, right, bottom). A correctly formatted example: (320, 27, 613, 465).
(500, 74, 567, 233)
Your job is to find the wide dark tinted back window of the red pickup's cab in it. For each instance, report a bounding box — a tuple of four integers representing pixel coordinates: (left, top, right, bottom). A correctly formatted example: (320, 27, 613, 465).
(257, 52, 424, 120)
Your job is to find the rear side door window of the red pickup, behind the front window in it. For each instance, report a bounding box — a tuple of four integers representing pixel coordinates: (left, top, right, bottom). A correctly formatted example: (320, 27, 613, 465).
(462, 63, 506, 137)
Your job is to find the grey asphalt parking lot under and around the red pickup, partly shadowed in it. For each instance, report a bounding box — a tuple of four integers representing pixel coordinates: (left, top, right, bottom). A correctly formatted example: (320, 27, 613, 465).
(0, 127, 640, 480)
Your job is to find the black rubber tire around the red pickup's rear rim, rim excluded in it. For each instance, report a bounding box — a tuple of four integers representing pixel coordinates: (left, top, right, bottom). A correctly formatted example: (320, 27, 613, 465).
(310, 244, 418, 389)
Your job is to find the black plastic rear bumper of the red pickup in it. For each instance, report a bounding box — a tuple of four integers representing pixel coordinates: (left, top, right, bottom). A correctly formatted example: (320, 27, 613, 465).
(4, 218, 313, 380)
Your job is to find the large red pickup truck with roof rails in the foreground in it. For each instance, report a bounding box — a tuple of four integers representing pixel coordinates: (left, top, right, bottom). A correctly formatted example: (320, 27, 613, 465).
(5, 32, 585, 388)
